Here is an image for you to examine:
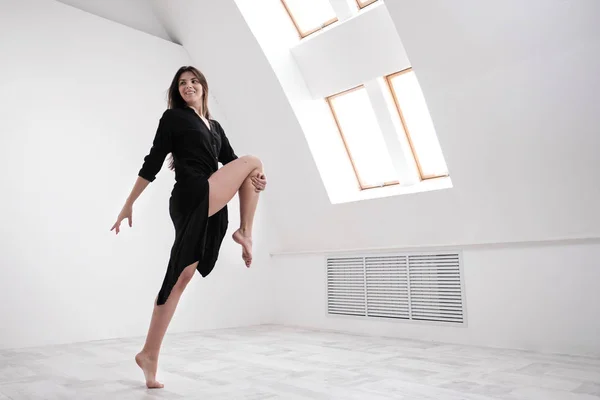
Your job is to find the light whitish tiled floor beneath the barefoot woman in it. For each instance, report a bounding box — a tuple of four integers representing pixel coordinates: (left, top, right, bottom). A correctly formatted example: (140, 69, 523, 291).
(0, 326, 600, 400)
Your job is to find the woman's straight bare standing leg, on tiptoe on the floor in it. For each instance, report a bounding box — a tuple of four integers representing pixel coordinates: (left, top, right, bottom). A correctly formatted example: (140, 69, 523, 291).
(135, 262, 198, 389)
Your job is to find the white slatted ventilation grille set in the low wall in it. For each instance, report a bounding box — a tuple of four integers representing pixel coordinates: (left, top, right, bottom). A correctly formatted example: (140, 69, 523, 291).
(327, 253, 464, 323)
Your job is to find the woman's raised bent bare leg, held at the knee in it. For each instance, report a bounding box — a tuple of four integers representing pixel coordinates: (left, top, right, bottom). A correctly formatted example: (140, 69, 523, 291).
(208, 156, 263, 267)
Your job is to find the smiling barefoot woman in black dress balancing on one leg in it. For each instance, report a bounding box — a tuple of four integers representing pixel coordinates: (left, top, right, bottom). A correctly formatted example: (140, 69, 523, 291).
(111, 66, 266, 388)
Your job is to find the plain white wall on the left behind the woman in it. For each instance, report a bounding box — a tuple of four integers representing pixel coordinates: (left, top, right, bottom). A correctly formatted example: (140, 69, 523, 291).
(0, 0, 270, 348)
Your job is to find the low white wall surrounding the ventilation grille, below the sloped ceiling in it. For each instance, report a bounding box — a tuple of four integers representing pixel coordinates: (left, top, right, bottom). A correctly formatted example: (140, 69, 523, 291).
(273, 241, 600, 356)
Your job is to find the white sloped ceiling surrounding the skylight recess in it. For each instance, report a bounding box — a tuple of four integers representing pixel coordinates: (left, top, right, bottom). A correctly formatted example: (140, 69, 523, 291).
(50, 0, 600, 252)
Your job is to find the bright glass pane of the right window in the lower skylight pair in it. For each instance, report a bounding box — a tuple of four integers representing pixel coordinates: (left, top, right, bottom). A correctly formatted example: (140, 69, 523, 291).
(390, 71, 448, 177)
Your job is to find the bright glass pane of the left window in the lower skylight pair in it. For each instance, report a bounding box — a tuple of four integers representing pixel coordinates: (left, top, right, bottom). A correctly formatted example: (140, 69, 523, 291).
(331, 88, 398, 187)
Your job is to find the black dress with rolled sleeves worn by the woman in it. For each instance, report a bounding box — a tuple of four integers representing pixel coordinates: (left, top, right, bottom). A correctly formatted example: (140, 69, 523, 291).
(138, 107, 237, 305)
